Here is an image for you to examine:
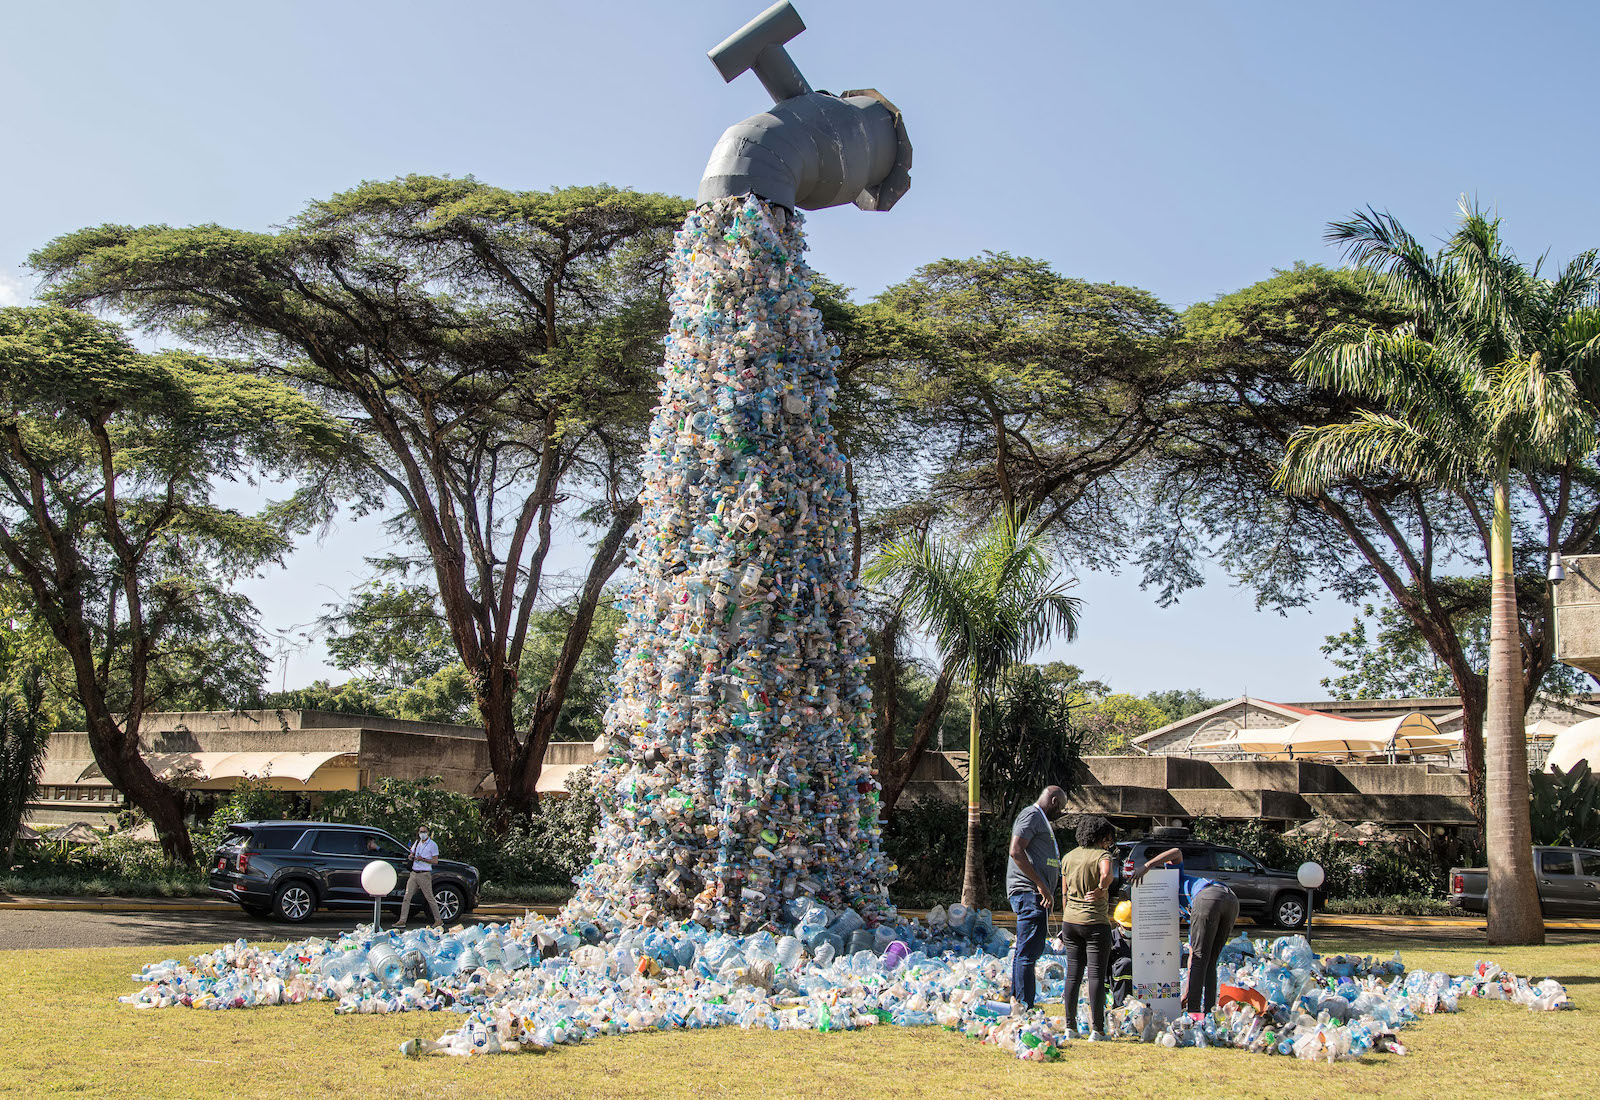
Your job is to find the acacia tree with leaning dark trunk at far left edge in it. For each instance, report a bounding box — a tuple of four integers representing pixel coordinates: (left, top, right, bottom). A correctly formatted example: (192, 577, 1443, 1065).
(0, 309, 354, 863)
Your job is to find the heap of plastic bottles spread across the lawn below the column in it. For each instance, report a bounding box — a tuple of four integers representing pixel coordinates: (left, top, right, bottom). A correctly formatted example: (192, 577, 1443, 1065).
(122, 903, 1573, 1062)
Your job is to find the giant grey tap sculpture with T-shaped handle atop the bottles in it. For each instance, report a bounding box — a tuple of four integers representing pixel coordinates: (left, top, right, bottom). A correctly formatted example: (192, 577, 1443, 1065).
(698, 0, 910, 209)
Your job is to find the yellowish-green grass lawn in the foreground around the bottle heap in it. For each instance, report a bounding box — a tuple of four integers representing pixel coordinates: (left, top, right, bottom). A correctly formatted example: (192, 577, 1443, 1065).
(0, 937, 1600, 1100)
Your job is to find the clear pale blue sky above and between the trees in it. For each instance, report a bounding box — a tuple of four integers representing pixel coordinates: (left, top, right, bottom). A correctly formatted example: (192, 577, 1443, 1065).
(0, 0, 1600, 699)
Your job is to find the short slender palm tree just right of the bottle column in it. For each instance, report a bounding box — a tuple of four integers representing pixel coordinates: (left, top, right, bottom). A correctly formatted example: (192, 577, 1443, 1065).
(866, 508, 1080, 905)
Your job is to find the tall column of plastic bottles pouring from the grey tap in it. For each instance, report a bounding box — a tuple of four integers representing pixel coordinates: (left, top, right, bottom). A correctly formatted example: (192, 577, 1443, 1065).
(574, 197, 894, 931)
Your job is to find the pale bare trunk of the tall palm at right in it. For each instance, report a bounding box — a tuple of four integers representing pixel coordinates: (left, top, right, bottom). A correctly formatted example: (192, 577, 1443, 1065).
(1485, 464, 1544, 943)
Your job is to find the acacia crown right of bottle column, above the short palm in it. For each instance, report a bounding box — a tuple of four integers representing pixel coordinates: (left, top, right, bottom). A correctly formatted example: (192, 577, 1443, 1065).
(851, 253, 1182, 566)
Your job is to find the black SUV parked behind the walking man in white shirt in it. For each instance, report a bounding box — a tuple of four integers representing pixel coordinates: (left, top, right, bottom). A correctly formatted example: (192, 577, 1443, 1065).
(211, 822, 478, 924)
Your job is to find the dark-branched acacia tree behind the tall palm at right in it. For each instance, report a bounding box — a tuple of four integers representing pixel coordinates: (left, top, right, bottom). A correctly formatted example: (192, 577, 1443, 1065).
(1139, 264, 1600, 823)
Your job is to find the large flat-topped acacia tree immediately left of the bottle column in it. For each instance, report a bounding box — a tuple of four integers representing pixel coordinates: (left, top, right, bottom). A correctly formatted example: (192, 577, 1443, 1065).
(32, 176, 688, 812)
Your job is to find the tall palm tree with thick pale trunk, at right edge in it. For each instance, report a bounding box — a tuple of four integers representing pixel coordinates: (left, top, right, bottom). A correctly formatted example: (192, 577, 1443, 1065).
(1278, 200, 1600, 943)
